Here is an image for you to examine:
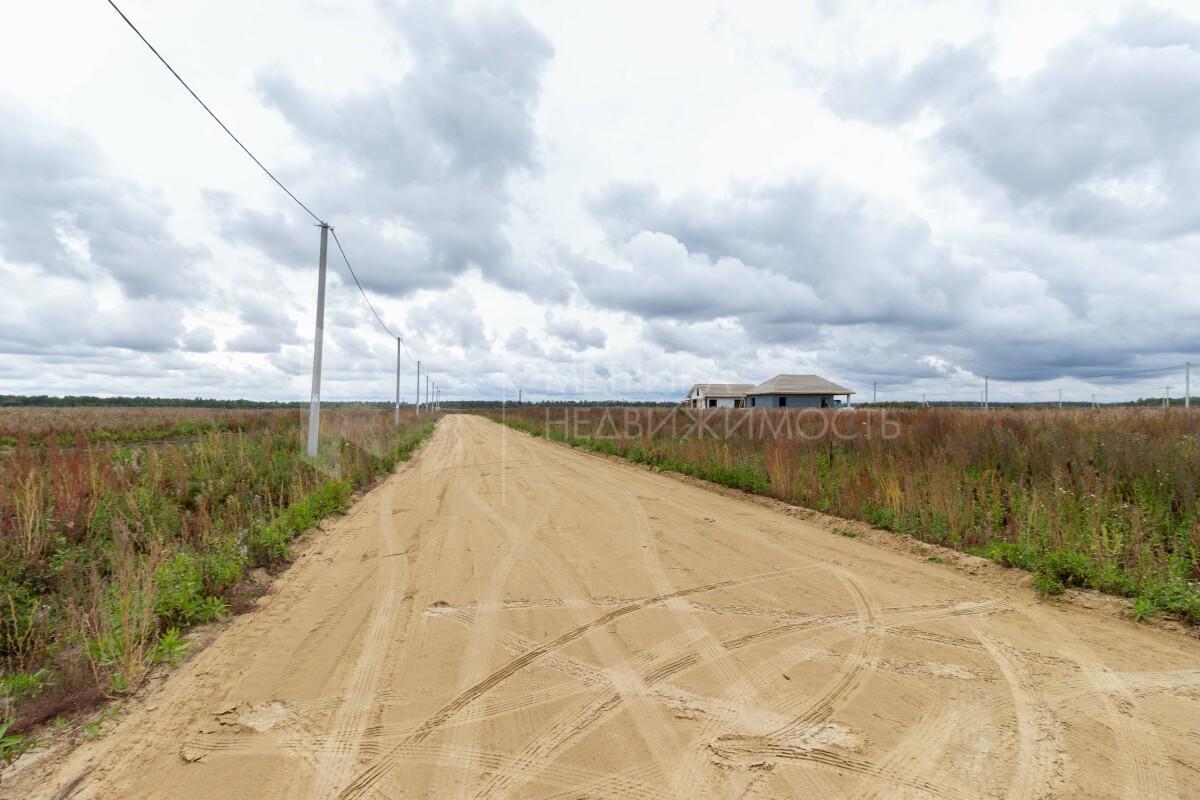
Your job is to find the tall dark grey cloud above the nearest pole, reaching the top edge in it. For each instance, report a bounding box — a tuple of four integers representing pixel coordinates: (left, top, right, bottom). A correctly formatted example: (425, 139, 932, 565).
(210, 0, 552, 296)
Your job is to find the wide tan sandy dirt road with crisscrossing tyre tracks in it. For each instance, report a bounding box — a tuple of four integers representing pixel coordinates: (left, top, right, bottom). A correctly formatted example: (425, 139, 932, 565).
(4, 416, 1200, 800)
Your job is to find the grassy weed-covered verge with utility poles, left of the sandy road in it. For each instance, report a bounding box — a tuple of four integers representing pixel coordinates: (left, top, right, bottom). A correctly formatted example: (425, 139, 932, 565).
(0, 408, 434, 764)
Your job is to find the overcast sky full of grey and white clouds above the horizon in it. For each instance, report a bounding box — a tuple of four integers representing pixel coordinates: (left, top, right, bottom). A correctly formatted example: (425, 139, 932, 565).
(0, 0, 1200, 399)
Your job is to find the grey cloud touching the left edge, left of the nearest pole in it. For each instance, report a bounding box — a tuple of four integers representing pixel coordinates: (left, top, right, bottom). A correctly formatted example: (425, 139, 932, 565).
(0, 96, 204, 297)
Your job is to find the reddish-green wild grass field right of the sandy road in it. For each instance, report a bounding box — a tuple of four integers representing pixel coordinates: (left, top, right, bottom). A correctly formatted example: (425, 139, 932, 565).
(488, 408, 1200, 624)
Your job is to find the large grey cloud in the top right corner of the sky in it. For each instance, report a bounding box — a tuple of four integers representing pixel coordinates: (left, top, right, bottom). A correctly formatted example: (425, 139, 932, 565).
(823, 10, 1200, 239)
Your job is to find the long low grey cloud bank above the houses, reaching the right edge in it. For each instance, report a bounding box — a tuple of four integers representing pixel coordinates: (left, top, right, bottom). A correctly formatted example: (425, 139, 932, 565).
(576, 170, 1198, 379)
